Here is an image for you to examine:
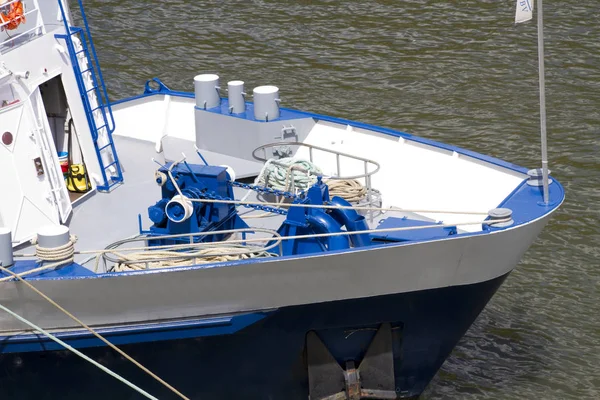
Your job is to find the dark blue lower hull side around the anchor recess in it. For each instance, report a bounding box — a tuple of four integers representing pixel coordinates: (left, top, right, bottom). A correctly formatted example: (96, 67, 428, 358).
(0, 275, 506, 400)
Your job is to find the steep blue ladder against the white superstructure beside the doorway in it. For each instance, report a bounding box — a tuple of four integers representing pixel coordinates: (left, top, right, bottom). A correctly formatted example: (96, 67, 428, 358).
(55, 0, 123, 191)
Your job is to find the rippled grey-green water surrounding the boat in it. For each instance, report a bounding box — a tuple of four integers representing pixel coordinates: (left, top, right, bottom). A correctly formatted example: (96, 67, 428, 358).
(83, 0, 600, 399)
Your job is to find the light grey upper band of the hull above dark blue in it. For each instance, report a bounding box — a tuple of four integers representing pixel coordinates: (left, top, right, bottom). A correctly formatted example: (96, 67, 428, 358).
(0, 214, 551, 333)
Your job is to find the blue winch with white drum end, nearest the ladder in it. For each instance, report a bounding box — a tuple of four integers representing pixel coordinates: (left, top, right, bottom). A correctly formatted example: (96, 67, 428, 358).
(148, 163, 248, 245)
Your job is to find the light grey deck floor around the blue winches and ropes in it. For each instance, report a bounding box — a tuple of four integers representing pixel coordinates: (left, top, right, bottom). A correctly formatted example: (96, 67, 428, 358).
(12, 136, 440, 272)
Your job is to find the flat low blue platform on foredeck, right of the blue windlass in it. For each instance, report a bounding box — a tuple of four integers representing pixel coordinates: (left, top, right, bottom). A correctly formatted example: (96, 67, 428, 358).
(371, 217, 456, 242)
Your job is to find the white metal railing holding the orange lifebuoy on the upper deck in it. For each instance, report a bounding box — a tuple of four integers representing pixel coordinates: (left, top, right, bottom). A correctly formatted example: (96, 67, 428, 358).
(0, 0, 45, 54)
